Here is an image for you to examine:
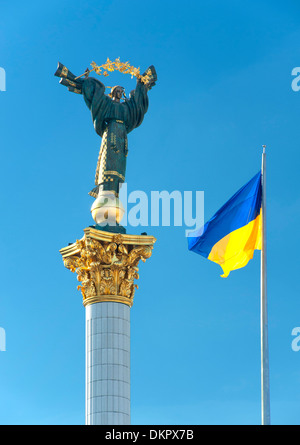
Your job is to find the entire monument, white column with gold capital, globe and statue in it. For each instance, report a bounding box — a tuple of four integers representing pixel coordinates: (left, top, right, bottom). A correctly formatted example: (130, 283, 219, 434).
(54, 58, 157, 425)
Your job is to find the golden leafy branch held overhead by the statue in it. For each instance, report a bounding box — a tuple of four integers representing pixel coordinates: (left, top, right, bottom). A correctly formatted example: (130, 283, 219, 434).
(76, 57, 151, 84)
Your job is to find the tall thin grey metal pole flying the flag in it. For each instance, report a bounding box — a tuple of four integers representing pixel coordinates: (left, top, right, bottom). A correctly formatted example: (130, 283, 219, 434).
(260, 145, 270, 425)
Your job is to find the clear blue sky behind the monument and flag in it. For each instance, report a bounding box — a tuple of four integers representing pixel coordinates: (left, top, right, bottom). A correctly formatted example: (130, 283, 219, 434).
(0, 0, 300, 425)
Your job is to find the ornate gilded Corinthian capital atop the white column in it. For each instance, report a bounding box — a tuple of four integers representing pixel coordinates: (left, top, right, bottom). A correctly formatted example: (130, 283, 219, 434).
(60, 228, 156, 307)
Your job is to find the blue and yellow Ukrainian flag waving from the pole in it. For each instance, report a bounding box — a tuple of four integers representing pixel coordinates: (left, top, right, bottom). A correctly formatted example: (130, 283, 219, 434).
(188, 171, 262, 277)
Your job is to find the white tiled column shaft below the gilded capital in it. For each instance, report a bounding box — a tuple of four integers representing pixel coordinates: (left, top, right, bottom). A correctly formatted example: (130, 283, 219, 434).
(85, 302, 130, 425)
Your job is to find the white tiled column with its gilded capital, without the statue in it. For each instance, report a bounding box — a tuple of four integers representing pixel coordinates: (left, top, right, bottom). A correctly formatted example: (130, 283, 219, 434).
(60, 227, 156, 425)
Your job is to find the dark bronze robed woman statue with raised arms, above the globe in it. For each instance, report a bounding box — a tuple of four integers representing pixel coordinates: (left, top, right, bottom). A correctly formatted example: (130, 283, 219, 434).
(55, 63, 157, 198)
